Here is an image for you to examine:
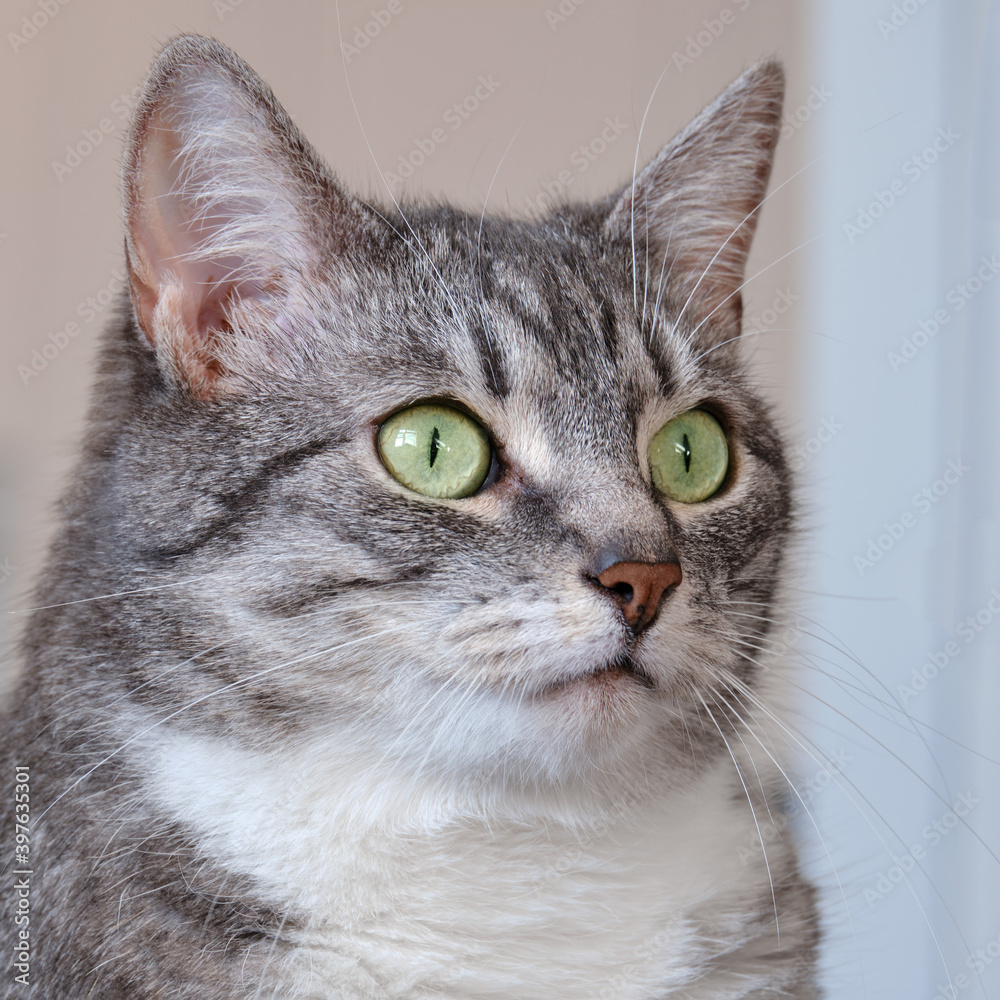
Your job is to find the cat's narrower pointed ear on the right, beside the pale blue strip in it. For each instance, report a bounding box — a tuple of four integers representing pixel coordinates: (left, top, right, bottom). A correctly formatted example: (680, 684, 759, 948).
(605, 61, 785, 343)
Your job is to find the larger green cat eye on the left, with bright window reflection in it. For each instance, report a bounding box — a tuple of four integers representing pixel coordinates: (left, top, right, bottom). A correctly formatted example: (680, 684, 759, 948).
(378, 403, 492, 500)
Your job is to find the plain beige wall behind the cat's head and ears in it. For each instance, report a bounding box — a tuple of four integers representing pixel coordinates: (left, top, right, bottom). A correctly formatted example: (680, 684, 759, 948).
(0, 0, 822, 660)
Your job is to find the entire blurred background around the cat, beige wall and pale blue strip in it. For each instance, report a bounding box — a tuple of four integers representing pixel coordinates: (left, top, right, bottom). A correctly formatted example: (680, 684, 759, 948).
(0, 0, 1000, 1000)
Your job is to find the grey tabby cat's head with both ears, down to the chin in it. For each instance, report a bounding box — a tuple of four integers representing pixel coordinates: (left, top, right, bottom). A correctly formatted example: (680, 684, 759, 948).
(105, 38, 789, 787)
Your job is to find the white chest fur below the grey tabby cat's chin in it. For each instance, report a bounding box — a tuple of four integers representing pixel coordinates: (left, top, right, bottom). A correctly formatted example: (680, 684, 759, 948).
(151, 735, 767, 1000)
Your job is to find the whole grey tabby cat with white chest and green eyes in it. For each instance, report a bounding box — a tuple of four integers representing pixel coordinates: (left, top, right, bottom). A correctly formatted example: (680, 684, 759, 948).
(0, 36, 818, 1000)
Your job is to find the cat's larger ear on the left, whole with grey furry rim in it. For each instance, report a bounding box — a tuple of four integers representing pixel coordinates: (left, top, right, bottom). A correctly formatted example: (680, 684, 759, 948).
(122, 35, 368, 398)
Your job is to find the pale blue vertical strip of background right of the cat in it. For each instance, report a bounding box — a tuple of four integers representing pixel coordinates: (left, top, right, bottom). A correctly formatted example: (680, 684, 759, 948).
(801, 0, 1000, 1000)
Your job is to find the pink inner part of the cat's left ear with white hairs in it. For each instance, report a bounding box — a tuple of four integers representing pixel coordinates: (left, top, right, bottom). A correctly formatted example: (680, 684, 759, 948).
(126, 66, 315, 369)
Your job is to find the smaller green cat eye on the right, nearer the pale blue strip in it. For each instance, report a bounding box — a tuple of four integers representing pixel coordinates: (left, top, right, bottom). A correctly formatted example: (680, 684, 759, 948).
(649, 410, 729, 503)
